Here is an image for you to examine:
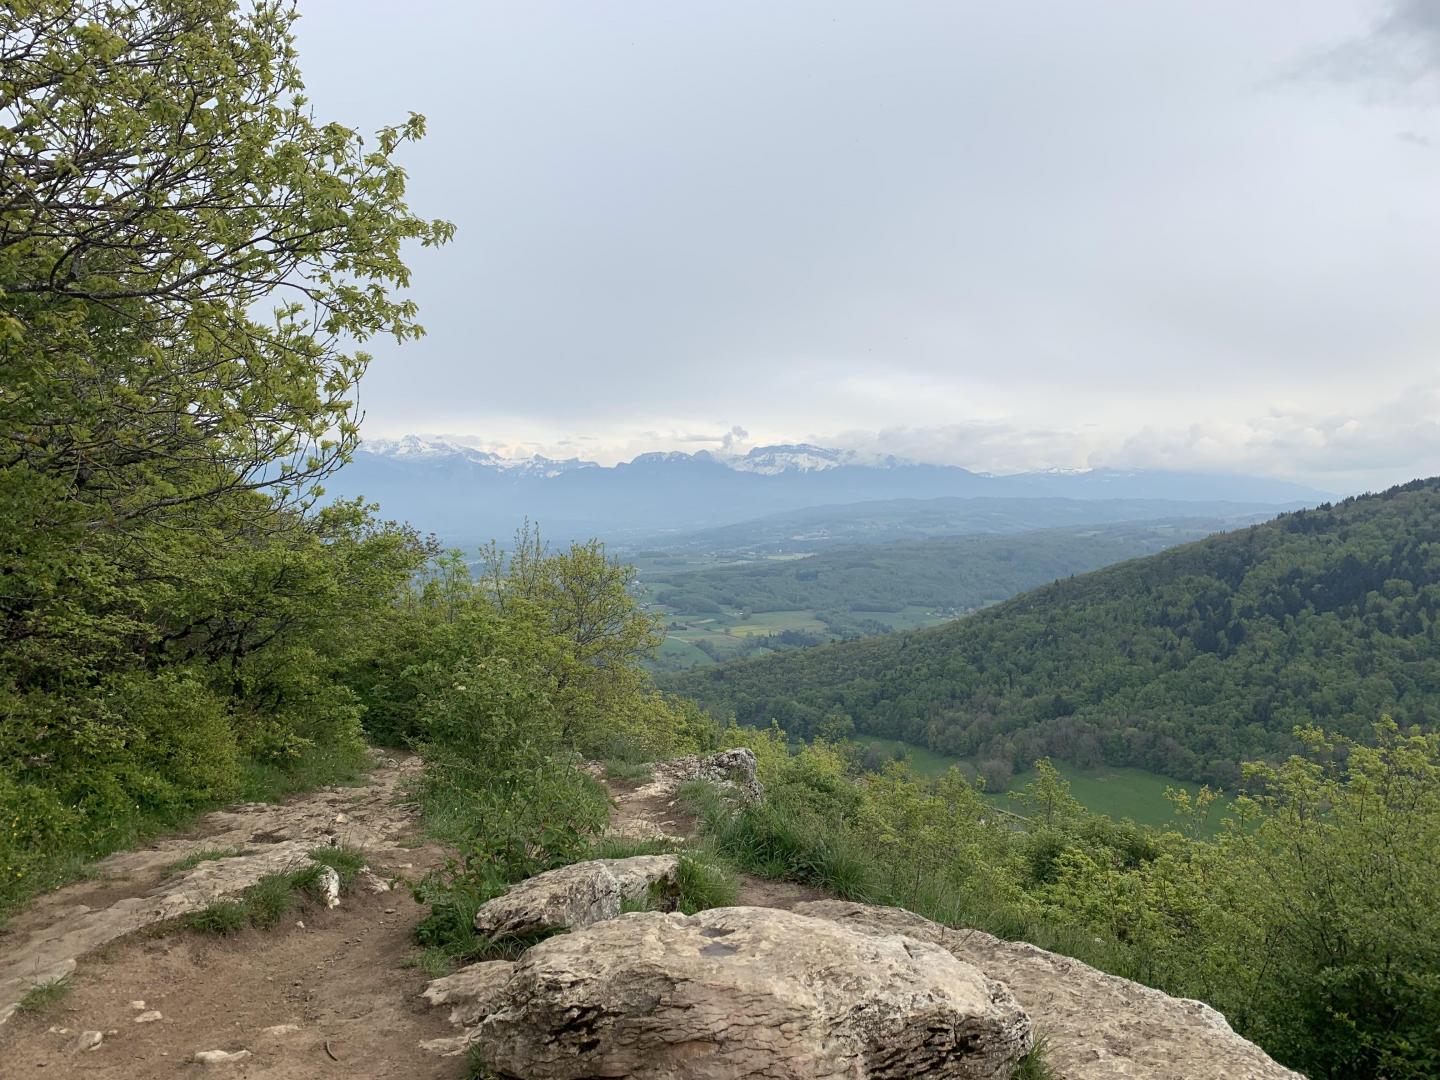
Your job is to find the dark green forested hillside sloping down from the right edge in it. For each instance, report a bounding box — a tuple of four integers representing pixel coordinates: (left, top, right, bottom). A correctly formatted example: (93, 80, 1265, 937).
(667, 480, 1440, 785)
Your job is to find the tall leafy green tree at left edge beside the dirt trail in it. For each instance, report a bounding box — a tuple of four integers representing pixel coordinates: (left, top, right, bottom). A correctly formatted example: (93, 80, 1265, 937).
(0, 0, 451, 910)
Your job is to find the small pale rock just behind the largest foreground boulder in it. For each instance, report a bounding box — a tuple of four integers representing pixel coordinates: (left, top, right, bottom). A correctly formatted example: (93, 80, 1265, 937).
(475, 855, 680, 937)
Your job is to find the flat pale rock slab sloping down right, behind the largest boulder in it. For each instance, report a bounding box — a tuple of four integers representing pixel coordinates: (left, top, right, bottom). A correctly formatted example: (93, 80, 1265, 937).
(795, 900, 1303, 1080)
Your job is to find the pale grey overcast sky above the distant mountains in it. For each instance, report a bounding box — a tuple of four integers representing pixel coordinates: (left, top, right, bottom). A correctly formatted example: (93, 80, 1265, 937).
(286, 0, 1440, 491)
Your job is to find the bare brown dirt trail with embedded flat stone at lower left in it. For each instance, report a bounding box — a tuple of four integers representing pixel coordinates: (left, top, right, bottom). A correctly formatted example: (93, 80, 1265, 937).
(0, 759, 465, 1080)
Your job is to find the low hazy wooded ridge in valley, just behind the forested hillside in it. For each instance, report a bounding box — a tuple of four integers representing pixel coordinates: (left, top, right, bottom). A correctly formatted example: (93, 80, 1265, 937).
(641, 521, 1218, 626)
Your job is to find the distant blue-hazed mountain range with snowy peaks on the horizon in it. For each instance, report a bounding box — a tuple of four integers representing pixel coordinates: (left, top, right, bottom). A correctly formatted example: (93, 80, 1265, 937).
(327, 435, 1326, 543)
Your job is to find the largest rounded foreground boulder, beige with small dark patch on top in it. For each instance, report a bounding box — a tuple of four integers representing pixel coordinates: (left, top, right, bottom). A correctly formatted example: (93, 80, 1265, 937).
(433, 907, 1032, 1080)
